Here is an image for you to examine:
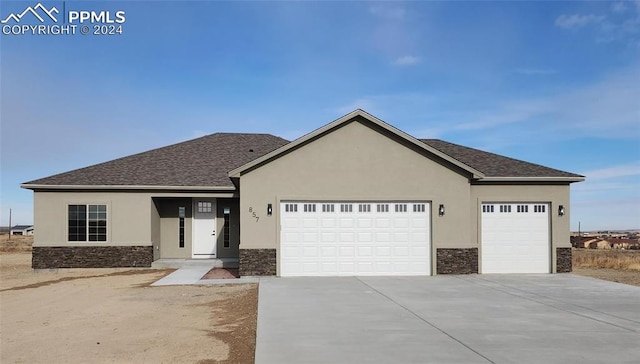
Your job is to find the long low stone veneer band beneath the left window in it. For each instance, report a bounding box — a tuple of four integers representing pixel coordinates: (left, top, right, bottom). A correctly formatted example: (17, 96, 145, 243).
(31, 246, 153, 269)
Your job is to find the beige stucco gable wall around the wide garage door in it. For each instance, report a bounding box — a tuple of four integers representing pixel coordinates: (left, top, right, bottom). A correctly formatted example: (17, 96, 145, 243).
(240, 122, 471, 255)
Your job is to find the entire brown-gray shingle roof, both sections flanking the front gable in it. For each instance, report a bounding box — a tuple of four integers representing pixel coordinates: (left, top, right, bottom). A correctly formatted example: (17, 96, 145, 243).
(25, 133, 582, 187)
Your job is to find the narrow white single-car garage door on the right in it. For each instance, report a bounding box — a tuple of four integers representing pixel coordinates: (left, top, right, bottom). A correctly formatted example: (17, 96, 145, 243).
(481, 203, 551, 273)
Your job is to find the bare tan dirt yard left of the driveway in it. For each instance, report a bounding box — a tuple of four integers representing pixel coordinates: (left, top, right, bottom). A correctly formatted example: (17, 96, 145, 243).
(0, 236, 258, 363)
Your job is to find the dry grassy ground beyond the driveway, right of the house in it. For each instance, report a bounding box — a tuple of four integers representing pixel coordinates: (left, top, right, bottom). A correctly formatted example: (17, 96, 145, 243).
(573, 249, 640, 286)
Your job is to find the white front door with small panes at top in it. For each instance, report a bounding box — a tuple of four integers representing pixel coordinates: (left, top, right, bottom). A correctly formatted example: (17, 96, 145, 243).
(193, 198, 216, 258)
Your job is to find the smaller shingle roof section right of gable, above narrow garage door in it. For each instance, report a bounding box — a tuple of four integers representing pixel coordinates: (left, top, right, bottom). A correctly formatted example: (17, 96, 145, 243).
(420, 139, 582, 178)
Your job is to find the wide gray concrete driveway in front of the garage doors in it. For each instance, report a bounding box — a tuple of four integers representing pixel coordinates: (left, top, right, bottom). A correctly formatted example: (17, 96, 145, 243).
(256, 274, 640, 364)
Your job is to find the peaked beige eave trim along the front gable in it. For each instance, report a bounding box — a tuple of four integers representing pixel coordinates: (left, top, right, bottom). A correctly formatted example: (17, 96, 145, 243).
(229, 109, 484, 179)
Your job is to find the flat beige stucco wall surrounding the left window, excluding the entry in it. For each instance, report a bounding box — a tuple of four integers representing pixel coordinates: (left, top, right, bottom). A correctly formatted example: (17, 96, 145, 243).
(33, 192, 151, 246)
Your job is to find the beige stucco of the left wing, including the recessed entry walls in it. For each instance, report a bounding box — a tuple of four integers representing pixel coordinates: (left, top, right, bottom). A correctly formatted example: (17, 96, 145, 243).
(34, 191, 240, 259)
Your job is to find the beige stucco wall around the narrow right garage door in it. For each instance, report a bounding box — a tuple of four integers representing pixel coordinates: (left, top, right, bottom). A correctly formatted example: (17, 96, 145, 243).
(470, 184, 571, 273)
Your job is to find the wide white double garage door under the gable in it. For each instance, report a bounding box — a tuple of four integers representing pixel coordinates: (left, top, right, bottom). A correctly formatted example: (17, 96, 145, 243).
(279, 201, 431, 276)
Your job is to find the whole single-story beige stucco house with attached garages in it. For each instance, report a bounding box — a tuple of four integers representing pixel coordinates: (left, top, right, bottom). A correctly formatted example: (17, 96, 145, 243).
(22, 110, 584, 276)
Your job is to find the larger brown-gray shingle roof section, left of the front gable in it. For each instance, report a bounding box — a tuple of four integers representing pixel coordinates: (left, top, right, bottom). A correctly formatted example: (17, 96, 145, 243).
(26, 133, 289, 187)
